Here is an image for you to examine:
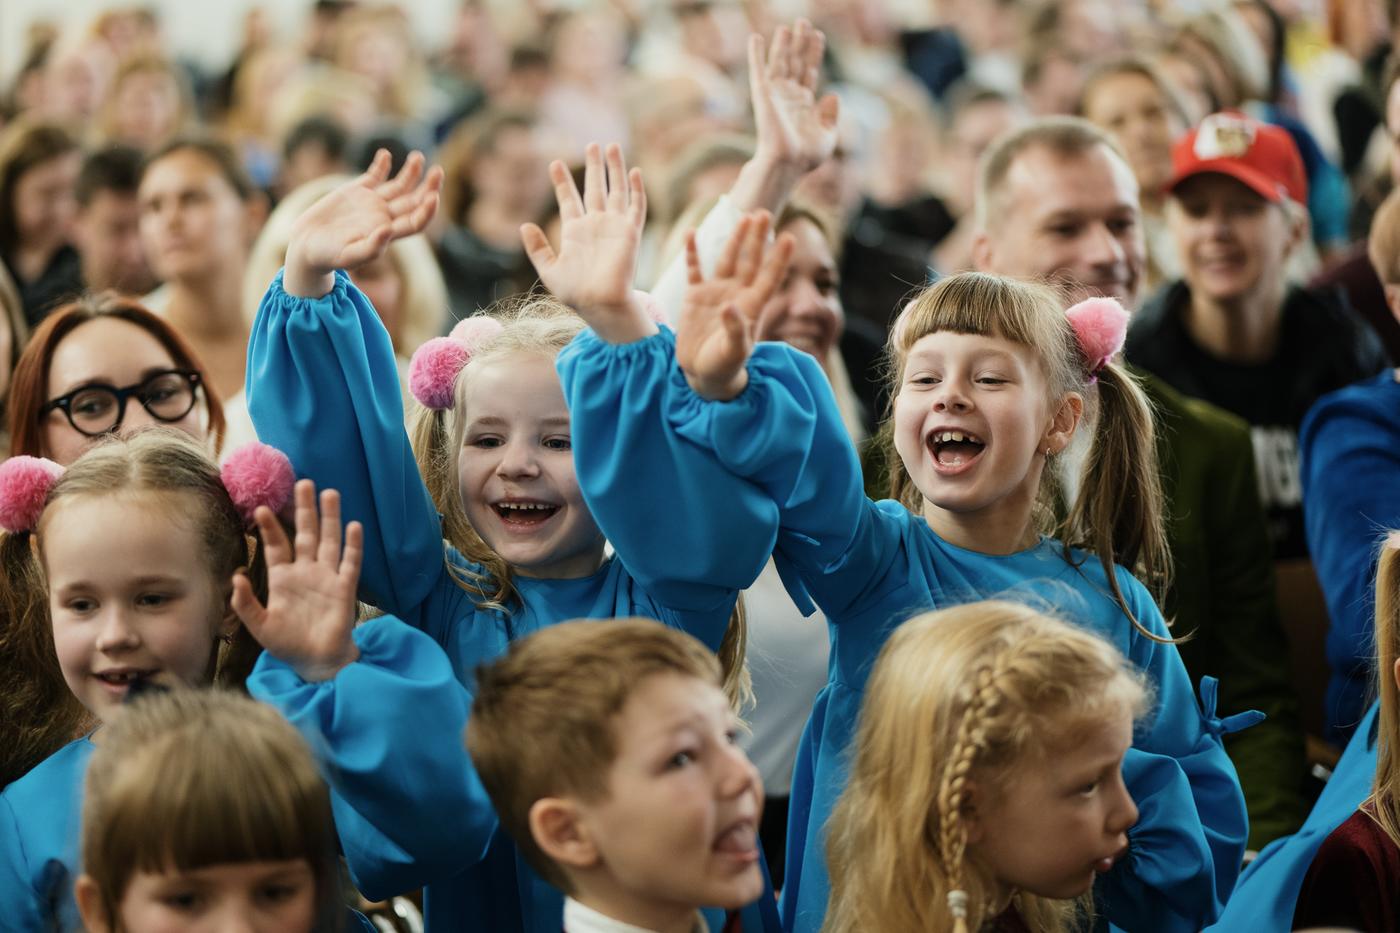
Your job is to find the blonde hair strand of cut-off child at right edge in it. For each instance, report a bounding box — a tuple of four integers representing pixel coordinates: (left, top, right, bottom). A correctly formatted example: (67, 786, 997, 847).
(1371, 531, 1400, 845)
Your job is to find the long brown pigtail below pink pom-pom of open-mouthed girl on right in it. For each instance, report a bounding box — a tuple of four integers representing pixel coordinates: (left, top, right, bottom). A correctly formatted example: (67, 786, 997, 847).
(1058, 355, 1172, 642)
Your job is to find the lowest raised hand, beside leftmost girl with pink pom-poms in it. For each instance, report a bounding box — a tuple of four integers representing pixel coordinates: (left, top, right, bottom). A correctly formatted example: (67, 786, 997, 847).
(232, 479, 364, 681)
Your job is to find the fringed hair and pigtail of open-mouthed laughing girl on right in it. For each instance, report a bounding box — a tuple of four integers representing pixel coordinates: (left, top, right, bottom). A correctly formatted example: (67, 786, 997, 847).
(882, 272, 1170, 642)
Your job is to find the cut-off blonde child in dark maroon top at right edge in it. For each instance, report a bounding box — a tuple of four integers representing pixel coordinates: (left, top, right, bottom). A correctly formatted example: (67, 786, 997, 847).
(1292, 532, 1400, 930)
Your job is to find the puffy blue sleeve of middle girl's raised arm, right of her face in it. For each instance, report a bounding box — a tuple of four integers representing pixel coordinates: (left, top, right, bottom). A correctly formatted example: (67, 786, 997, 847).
(557, 328, 777, 627)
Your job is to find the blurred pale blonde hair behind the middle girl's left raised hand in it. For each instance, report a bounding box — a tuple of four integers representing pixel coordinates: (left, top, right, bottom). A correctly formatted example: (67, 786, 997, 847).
(244, 175, 448, 359)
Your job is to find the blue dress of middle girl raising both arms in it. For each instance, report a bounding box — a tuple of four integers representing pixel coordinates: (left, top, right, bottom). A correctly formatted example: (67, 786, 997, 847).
(246, 272, 777, 933)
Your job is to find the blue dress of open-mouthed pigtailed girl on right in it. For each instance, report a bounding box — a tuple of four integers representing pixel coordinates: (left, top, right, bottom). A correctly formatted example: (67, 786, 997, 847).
(574, 333, 1257, 933)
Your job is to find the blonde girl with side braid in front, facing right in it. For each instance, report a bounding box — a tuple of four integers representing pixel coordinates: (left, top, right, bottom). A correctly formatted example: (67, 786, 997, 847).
(822, 601, 1147, 933)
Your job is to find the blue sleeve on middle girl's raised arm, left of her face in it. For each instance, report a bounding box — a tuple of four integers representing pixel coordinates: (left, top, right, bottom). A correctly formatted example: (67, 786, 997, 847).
(246, 272, 447, 621)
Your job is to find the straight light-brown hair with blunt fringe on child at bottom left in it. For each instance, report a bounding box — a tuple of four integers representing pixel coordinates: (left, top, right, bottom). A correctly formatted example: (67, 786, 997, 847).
(83, 689, 344, 930)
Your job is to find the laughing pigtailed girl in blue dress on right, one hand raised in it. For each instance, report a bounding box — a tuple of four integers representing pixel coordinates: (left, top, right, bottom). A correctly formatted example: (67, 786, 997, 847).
(563, 243, 1253, 930)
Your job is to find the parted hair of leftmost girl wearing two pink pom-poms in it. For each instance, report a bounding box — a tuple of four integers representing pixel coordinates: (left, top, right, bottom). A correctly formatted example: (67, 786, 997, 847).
(0, 427, 266, 780)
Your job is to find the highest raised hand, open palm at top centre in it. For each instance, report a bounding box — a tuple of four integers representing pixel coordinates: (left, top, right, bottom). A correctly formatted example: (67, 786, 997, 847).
(749, 20, 840, 174)
